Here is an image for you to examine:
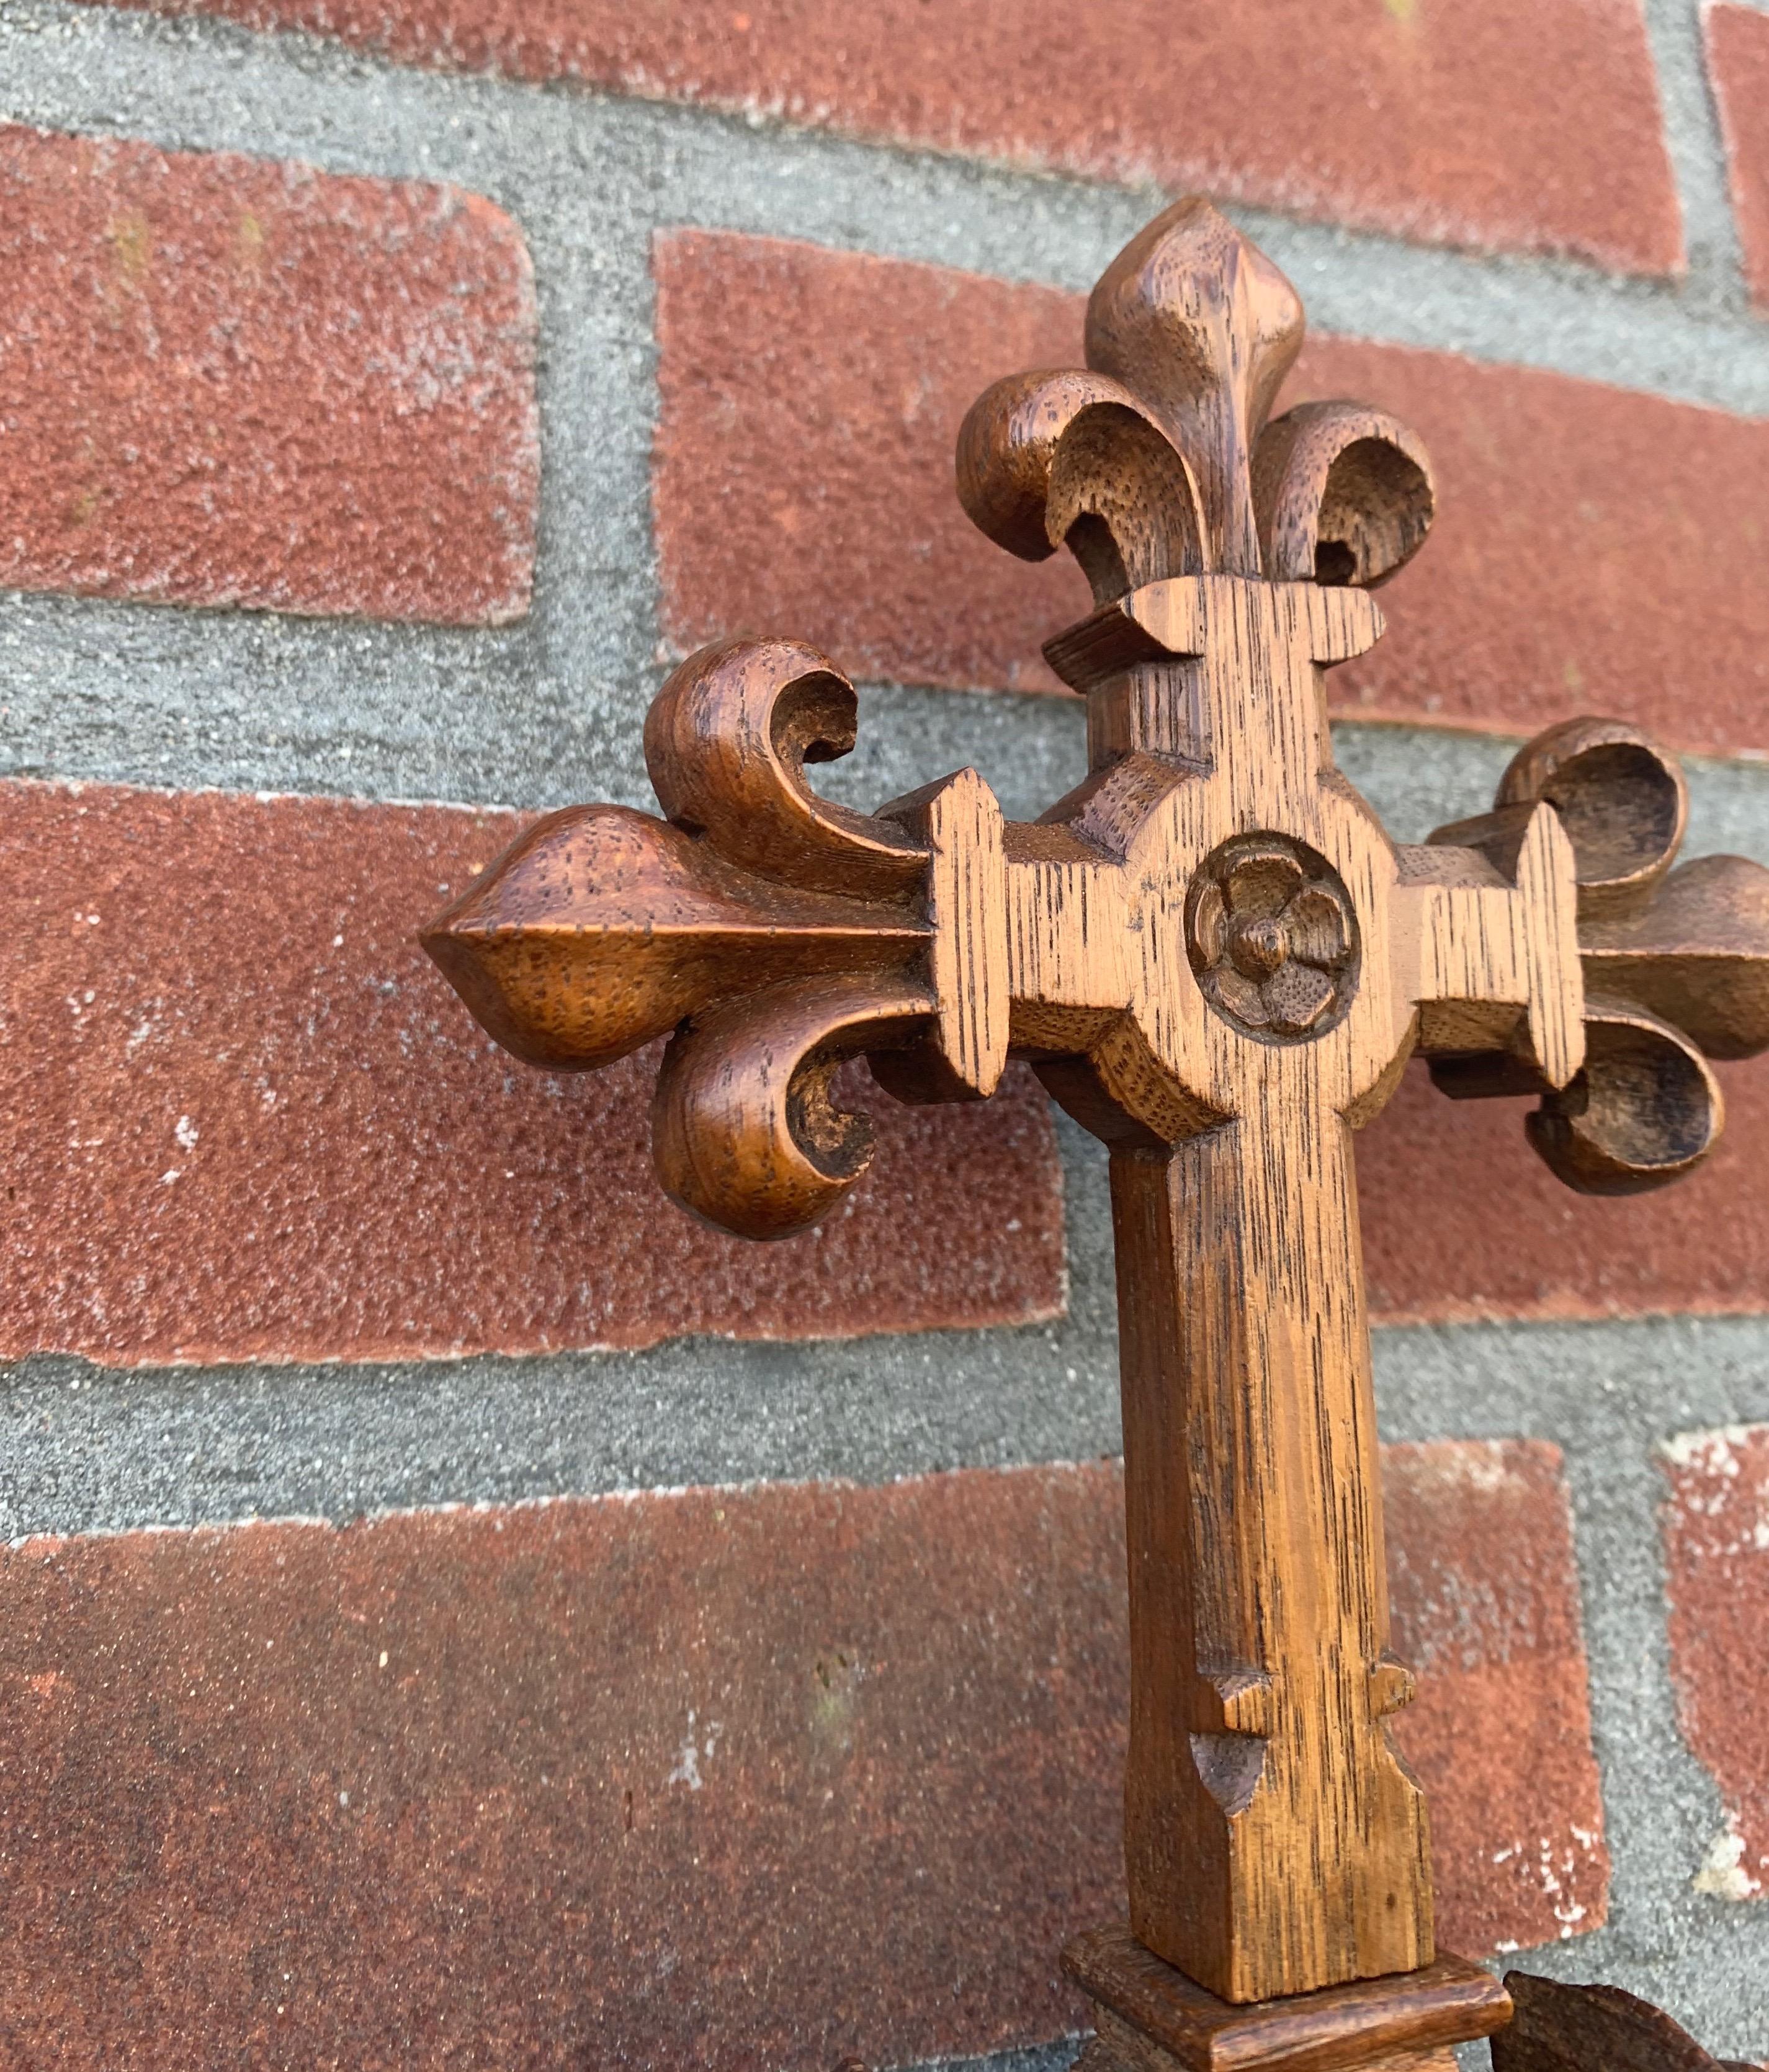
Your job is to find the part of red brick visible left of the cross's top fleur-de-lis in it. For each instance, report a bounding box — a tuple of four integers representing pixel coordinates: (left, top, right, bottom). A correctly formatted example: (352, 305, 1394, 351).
(653, 230, 1090, 696)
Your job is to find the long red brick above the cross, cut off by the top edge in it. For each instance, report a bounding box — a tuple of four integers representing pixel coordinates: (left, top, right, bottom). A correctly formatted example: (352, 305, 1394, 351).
(86, 0, 1682, 274)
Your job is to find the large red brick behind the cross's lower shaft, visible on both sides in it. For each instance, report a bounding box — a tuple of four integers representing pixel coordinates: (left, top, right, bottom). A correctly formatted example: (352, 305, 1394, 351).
(0, 1446, 1603, 2072)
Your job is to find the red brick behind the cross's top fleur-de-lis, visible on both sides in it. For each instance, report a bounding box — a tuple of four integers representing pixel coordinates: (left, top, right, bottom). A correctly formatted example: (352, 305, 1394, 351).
(655, 232, 1769, 762)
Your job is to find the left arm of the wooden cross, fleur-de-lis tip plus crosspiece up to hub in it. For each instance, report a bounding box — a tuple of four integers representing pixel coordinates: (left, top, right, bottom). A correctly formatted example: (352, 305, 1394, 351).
(421, 640, 1170, 1237)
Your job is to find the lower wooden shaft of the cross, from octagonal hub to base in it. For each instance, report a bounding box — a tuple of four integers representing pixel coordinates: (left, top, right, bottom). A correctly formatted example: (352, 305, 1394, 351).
(1113, 1135, 1433, 1999)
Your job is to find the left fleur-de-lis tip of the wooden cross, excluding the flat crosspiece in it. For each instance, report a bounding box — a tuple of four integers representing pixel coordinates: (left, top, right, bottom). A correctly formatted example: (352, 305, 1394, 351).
(421, 640, 953, 1237)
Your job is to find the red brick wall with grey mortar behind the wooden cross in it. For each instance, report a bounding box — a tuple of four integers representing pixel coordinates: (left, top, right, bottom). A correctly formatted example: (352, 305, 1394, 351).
(0, 0, 1769, 2072)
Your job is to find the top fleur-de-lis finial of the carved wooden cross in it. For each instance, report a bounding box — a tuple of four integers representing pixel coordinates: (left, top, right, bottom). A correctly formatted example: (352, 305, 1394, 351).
(959, 197, 1433, 603)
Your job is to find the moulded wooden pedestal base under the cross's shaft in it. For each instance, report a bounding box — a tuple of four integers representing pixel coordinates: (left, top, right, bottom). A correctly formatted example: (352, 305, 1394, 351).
(1063, 1927, 1512, 2072)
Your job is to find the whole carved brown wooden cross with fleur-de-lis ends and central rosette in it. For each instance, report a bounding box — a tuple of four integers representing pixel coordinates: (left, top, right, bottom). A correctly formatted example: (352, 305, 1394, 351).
(424, 201, 1769, 2064)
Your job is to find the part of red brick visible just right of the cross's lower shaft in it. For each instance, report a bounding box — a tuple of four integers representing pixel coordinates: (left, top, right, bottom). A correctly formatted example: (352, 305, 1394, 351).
(1384, 1440, 1610, 1952)
